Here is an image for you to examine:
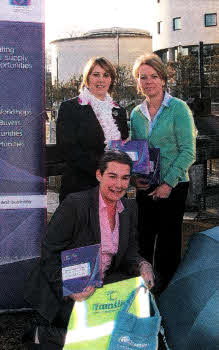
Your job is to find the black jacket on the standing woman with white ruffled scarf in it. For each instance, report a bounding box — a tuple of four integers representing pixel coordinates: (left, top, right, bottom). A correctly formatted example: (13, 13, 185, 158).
(56, 97, 128, 200)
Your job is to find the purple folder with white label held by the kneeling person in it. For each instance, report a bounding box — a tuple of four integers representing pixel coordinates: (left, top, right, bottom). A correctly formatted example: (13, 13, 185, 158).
(61, 244, 103, 296)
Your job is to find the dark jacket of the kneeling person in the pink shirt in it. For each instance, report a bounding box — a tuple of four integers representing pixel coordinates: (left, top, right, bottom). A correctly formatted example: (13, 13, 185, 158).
(25, 187, 143, 322)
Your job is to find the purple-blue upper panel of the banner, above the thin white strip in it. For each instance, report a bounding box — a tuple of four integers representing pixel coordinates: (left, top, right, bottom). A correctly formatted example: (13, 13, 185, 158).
(0, 21, 44, 193)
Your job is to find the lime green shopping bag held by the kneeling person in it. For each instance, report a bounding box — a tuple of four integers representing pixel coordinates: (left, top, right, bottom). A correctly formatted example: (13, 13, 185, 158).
(63, 277, 149, 350)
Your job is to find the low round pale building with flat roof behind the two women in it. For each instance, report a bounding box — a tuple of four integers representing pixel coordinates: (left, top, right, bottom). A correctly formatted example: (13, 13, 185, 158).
(50, 27, 152, 82)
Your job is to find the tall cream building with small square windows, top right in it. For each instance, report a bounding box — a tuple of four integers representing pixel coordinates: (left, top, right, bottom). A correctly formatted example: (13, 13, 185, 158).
(153, 0, 219, 60)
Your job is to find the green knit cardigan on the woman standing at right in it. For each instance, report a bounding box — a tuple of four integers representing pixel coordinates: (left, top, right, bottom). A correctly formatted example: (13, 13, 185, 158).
(130, 97, 197, 187)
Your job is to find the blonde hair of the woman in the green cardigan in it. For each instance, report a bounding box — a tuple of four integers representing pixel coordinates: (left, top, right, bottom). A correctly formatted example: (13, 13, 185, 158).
(132, 53, 167, 92)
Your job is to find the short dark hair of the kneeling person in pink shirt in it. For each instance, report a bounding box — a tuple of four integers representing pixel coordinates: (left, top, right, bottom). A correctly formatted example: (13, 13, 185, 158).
(98, 150, 132, 175)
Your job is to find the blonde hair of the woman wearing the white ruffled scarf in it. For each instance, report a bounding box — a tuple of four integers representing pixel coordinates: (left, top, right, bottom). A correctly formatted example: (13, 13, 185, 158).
(80, 57, 116, 94)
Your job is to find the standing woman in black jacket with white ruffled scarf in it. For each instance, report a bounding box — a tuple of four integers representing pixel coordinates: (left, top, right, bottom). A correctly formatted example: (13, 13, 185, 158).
(56, 57, 128, 202)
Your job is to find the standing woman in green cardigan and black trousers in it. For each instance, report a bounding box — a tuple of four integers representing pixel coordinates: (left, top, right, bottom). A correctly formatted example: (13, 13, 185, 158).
(130, 54, 196, 293)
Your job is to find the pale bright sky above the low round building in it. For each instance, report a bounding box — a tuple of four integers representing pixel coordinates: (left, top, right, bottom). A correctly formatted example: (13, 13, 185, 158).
(45, 0, 154, 45)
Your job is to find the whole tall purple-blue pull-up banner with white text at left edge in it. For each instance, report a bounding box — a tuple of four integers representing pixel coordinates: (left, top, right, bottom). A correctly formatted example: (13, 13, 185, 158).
(0, 0, 46, 310)
